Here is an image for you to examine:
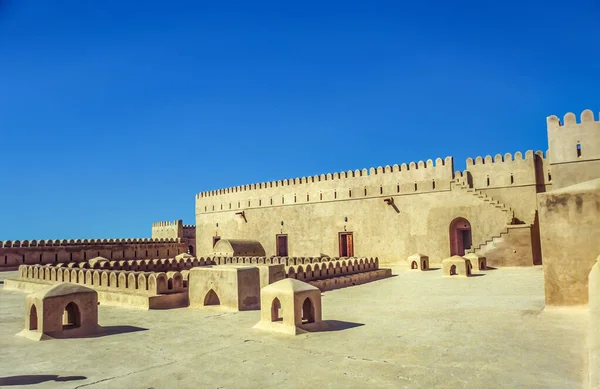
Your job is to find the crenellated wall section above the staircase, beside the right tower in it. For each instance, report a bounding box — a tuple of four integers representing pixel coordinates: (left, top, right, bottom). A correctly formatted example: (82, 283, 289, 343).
(466, 150, 545, 223)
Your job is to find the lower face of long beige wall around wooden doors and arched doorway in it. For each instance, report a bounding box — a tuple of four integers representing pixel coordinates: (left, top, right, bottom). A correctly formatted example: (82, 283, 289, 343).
(196, 183, 506, 263)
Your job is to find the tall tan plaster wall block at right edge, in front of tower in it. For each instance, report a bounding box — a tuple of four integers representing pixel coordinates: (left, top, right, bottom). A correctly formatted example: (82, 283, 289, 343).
(538, 179, 600, 305)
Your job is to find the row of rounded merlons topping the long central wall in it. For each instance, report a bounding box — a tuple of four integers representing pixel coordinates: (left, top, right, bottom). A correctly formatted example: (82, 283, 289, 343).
(196, 157, 454, 199)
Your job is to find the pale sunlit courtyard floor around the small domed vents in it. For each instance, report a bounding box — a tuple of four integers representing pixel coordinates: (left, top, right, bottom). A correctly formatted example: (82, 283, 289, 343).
(0, 267, 588, 389)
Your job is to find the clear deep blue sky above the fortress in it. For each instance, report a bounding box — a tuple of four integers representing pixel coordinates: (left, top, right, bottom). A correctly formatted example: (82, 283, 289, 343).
(0, 0, 600, 240)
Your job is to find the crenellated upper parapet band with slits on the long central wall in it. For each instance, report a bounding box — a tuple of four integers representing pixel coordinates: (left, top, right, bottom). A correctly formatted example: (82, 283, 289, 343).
(196, 157, 453, 214)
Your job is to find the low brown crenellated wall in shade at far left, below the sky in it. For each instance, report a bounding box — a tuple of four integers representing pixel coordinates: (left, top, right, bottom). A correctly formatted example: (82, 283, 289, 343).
(0, 239, 188, 270)
